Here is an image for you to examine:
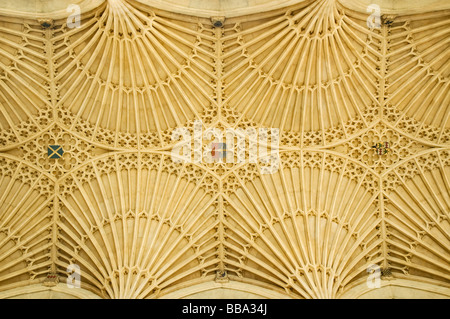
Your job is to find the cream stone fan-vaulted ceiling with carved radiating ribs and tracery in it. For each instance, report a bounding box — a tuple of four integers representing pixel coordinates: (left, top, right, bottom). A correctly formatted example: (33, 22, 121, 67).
(0, 0, 450, 298)
